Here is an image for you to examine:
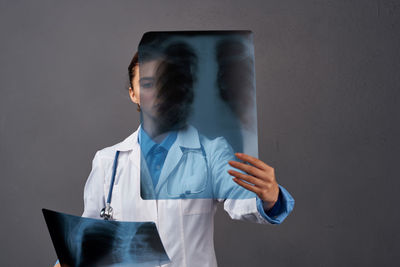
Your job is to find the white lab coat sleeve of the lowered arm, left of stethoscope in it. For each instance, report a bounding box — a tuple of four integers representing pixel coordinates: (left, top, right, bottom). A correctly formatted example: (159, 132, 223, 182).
(82, 151, 105, 219)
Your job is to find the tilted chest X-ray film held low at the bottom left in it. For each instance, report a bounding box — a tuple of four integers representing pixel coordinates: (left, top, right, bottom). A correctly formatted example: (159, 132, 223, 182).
(43, 209, 170, 267)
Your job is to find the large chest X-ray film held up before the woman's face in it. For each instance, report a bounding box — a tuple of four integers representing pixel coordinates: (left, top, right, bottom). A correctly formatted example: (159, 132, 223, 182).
(134, 31, 258, 199)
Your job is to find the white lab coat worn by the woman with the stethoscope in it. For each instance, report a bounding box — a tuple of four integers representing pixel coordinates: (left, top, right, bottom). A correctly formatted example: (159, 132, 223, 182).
(82, 126, 294, 267)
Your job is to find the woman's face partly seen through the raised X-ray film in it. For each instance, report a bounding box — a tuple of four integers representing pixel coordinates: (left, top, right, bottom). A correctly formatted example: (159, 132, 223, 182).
(129, 60, 159, 119)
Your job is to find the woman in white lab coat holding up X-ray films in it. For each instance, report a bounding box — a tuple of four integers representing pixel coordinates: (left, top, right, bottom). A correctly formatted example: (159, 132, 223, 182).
(54, 46, 294, 267)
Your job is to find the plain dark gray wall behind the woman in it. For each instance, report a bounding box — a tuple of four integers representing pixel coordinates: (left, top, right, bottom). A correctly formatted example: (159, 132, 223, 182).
(0, 0, 400, 266)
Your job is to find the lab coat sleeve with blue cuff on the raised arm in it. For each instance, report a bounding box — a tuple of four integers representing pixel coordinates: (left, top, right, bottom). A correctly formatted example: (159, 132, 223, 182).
(210, 137, 294, 224)
